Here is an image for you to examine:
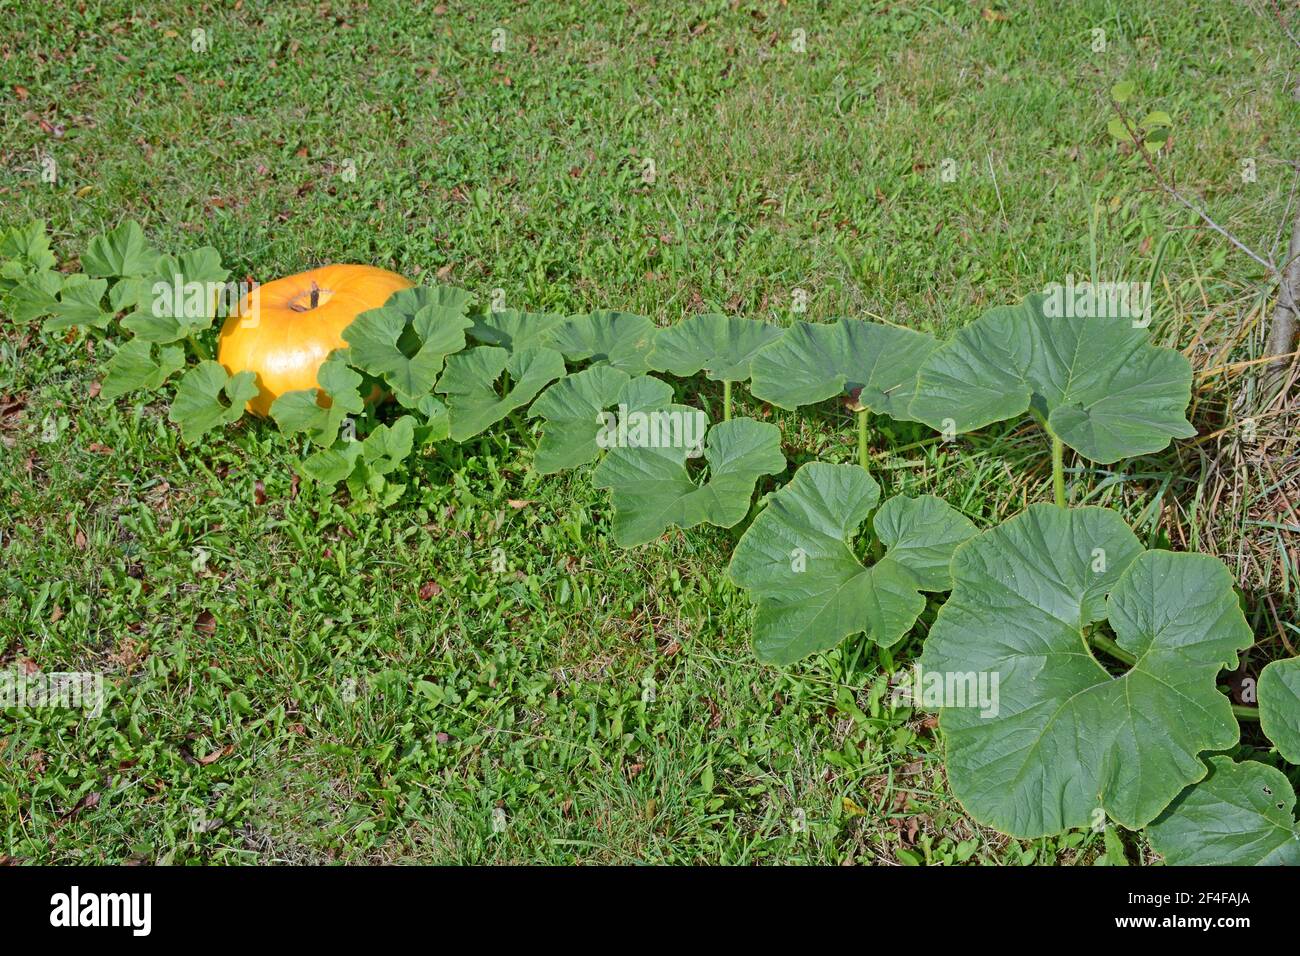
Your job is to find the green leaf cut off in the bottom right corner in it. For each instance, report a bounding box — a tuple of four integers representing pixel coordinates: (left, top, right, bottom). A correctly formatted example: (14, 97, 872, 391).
(1147, 757, 1300, 866)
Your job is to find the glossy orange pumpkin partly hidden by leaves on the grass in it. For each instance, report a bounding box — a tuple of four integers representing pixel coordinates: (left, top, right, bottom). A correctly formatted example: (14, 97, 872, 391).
(217, 265, 413, 415)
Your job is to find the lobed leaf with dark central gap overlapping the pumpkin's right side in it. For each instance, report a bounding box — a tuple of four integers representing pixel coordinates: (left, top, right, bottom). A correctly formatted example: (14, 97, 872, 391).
(343, 286, 472, 408)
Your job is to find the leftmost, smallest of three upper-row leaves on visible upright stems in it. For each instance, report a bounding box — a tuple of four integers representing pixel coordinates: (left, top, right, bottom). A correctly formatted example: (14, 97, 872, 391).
(647, 315, 783, 381)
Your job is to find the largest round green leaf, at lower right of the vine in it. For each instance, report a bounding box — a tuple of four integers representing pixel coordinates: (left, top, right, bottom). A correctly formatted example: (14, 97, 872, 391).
(922, 505, 1252, 838)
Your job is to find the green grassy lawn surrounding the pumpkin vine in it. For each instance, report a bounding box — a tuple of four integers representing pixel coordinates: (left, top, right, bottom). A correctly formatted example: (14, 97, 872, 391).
(0, 0, 1300, 864)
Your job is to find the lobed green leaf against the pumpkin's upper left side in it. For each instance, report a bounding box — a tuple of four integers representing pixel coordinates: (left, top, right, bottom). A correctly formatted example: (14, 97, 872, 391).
(120, 246, 230, 345)
